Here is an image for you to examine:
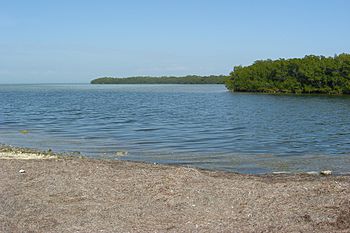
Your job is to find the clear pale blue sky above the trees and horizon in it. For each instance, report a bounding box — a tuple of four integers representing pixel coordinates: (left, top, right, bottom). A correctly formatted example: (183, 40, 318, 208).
(0, 0, 350, 83)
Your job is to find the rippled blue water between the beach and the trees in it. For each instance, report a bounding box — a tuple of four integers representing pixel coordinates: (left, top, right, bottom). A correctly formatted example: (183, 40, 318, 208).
(0, 84, 350, 173)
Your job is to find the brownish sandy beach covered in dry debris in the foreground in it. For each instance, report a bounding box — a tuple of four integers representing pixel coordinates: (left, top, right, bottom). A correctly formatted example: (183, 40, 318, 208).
(0, 148, 350, 232)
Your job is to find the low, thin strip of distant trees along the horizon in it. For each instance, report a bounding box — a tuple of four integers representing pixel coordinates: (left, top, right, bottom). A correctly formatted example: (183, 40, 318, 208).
(91, 75, 227, 84)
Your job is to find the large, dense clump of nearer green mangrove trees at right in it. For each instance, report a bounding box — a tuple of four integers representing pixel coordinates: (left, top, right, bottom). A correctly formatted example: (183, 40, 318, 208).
(225, 54, 350, 94)
